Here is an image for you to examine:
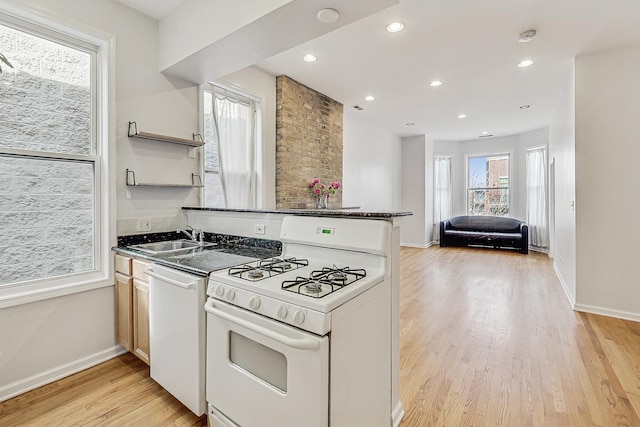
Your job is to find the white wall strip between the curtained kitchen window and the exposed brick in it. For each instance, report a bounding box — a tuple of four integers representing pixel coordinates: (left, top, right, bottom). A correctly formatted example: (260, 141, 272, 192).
(216, 67, 276, 209)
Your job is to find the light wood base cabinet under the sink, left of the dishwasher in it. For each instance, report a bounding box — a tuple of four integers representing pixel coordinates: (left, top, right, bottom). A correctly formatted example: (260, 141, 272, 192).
(115, 254, 150, 364)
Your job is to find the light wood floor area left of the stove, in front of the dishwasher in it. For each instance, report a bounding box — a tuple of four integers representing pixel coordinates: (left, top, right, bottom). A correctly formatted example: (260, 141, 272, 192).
(0, 353, 207, 427)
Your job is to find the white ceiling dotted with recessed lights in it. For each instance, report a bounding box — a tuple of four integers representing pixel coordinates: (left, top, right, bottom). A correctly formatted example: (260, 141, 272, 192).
(119, 0, 640, 140)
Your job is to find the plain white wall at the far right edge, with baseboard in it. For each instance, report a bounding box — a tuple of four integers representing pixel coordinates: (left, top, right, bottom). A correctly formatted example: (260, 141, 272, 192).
(575, 45, 640, 321)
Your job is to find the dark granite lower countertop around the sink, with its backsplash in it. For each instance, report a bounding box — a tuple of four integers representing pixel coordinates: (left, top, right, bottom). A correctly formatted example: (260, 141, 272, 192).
(113, 232, 282, 276)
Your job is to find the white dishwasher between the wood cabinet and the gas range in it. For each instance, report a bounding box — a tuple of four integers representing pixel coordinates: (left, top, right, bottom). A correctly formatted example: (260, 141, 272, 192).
(145, 264, 207, 416)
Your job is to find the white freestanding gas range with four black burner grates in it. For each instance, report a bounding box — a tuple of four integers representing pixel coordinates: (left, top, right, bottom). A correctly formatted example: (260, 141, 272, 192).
(205, 216, 392, 427)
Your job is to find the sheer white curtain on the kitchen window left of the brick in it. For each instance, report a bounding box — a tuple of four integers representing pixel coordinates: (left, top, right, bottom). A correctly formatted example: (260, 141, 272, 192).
(211, 85, 256, 209)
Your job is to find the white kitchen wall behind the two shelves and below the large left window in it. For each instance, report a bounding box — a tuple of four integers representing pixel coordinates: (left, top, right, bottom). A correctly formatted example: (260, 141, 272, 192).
(0, 0, 198, 400)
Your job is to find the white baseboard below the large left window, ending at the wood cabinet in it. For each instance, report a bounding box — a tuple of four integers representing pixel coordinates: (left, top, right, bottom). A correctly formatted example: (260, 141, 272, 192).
(0, 345, 127, 402)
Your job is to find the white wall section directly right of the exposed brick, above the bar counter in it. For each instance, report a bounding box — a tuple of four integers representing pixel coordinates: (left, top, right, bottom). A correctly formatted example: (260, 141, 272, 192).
(342, 108, 401, 212)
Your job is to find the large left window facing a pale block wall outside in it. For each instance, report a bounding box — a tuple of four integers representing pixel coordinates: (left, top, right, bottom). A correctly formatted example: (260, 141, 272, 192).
(0, 13, 108, 298)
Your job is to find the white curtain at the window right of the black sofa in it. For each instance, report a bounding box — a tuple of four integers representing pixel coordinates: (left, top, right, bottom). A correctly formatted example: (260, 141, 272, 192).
(526, 147, 549, 249)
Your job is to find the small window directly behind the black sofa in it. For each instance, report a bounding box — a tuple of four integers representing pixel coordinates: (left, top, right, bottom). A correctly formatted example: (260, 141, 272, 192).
(467, 154, 510, 216)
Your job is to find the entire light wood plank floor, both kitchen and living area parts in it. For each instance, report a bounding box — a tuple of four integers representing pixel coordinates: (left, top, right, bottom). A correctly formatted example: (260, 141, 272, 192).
(0, 247, 640, 427)
